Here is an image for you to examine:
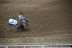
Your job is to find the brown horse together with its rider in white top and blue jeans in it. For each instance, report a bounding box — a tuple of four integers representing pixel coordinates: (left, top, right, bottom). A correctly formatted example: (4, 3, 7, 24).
(18, 12, 28, 31)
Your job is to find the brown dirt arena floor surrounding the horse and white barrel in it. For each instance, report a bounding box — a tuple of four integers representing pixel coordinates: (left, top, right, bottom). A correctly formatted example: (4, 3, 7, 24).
(0, 0, 72, 44)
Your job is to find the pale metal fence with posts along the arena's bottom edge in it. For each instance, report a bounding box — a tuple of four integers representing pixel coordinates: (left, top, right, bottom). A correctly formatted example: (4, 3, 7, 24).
(0, 45, 72, 48)
